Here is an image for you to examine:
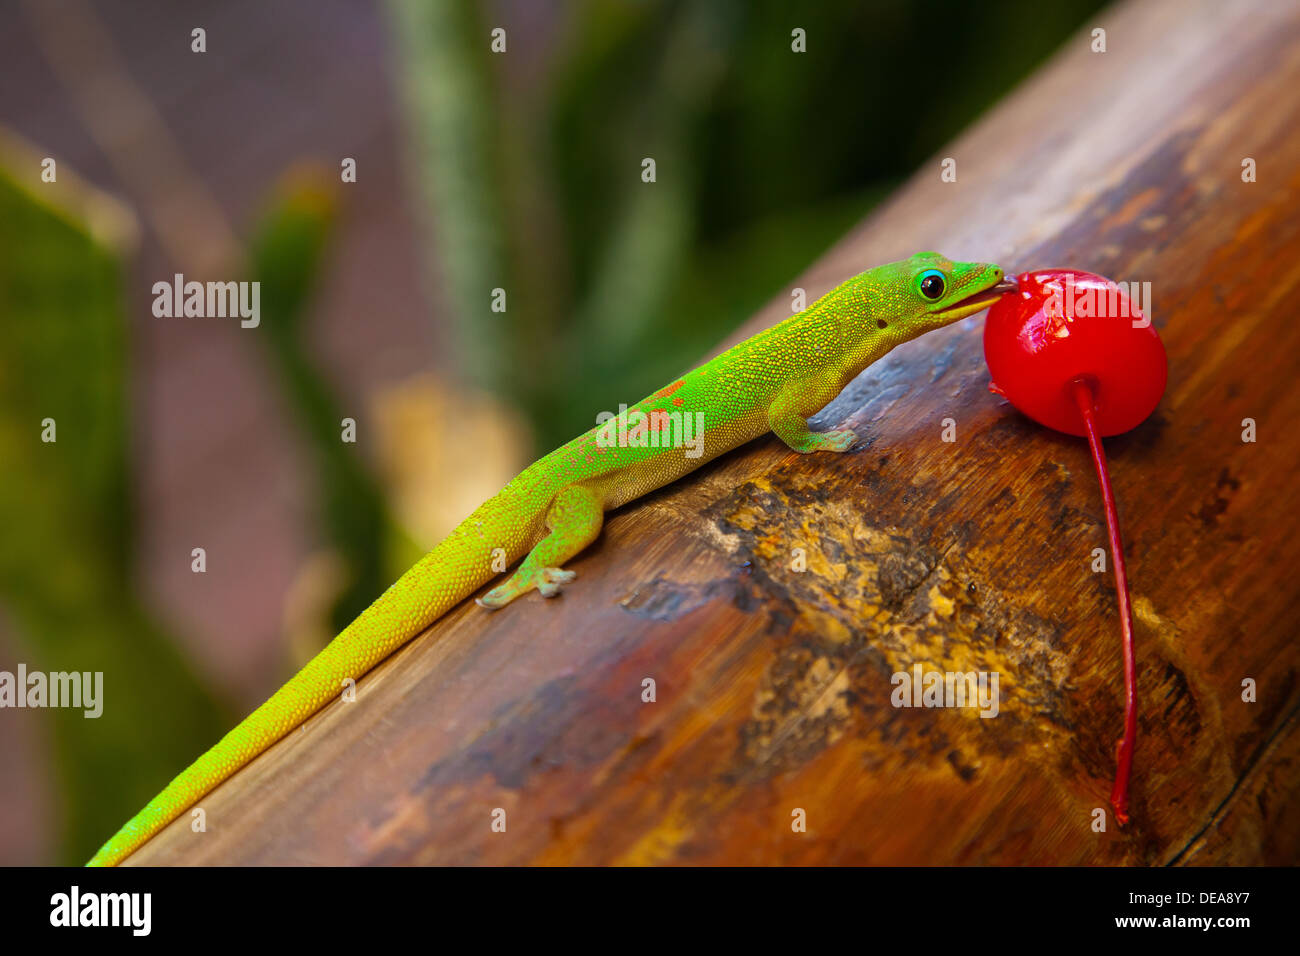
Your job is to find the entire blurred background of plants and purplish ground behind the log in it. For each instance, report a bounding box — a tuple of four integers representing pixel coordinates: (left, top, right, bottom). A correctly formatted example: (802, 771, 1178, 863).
(0, 0, 1100, 865)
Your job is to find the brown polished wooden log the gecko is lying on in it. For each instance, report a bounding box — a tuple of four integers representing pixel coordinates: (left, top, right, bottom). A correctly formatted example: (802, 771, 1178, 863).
(133, 3, 1300, 864)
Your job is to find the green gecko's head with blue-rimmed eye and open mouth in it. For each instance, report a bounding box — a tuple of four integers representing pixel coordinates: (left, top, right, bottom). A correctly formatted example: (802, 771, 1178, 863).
(894, 252, 1017, 338)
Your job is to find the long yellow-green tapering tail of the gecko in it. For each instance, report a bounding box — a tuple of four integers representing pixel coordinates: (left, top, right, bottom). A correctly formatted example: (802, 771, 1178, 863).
(86, 490, 545, 866)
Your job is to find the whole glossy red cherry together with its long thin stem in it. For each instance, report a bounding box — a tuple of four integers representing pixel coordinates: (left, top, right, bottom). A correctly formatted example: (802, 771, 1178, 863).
(984, 269, 1169, 823)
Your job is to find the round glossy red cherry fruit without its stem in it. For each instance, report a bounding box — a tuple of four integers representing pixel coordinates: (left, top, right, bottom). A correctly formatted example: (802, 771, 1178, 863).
(984, 269, 1167, 436)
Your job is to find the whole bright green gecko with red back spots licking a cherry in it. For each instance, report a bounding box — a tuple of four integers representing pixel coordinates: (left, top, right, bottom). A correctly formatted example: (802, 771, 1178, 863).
(88, 252, 1011, 866)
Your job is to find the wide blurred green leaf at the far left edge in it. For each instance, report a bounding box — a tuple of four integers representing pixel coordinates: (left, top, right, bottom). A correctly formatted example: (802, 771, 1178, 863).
(0, 169, 229, 864)
